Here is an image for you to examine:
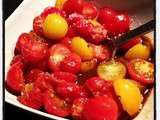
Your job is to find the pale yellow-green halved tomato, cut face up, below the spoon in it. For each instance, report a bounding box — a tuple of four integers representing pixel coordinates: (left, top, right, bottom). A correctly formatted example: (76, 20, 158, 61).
(97, 61, 126, 81)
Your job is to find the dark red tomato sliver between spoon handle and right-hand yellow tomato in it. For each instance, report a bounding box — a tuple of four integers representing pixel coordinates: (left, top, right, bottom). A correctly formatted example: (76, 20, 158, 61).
(120, 37, 142, 51)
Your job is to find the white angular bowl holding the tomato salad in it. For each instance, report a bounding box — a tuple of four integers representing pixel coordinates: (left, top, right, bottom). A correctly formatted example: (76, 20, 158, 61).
(5, 0, 154, 120)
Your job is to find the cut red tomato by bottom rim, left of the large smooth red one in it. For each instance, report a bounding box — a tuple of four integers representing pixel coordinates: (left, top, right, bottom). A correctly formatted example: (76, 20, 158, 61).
(43, 91, 70, 117)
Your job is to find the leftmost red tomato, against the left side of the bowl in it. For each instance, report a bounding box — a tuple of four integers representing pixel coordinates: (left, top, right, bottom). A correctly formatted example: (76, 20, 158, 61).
(6, 62, 24, 93)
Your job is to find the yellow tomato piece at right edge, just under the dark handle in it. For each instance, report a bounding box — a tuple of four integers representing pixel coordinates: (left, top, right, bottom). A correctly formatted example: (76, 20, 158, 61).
(125, 43, 150, 60)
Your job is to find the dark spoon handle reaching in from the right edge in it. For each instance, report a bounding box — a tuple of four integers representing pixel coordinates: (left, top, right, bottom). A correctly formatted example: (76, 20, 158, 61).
(113, 20, 155, 47)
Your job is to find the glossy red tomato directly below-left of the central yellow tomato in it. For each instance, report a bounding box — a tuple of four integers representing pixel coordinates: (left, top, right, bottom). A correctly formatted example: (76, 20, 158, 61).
(61, 53, 81, 74)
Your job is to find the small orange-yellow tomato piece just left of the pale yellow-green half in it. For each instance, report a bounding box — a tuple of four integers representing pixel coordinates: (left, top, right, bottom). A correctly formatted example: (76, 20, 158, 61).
(81, 59, 97, 72)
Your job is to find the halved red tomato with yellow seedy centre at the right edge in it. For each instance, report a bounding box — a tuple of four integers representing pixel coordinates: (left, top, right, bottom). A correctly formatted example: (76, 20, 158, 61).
(127, 59, 154, 84)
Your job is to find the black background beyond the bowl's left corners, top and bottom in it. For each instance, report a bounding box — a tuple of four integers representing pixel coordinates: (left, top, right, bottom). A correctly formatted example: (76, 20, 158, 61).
(3, 0, 51, 120)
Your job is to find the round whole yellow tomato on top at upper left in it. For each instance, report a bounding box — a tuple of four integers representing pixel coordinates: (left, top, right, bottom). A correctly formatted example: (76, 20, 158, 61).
(43, 13, 68, 39)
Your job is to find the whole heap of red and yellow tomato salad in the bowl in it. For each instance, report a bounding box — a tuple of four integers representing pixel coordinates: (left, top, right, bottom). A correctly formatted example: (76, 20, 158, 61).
(6, 0, 154, 120)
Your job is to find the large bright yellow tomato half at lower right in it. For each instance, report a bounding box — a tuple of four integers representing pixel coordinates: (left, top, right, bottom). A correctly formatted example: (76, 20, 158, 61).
(113, 79, 143, 116)
